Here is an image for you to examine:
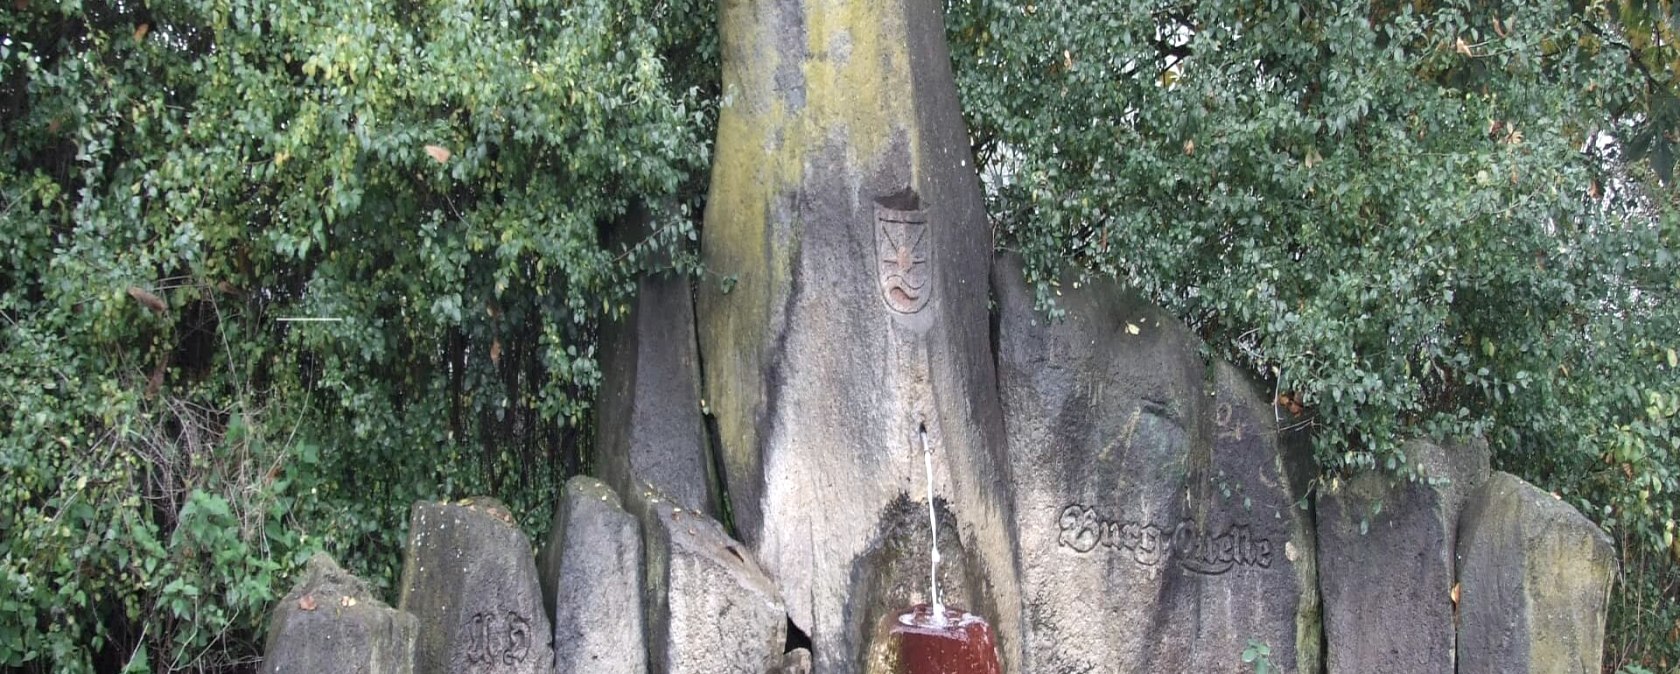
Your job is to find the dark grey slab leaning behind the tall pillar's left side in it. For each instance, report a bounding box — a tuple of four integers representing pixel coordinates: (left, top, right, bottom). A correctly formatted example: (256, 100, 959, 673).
(596, 252, 721, 516)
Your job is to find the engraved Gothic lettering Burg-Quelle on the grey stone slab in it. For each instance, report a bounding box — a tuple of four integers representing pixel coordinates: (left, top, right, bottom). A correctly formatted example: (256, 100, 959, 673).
(1057, 504, 1272, 575)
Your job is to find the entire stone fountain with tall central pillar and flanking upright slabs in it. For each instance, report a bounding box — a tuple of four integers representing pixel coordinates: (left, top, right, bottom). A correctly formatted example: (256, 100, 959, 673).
(264, 0, 1614, 674)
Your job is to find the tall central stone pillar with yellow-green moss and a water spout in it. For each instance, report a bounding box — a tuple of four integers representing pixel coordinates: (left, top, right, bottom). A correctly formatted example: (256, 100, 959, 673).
(699, 0, 1020, 672)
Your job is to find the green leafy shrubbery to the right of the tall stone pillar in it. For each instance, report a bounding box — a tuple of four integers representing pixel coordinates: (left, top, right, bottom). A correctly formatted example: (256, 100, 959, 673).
(948, 0, 1680, 654)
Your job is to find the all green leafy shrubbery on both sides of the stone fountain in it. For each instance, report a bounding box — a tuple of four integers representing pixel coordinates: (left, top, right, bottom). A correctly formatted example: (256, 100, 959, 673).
(0, 0, 1680, 671)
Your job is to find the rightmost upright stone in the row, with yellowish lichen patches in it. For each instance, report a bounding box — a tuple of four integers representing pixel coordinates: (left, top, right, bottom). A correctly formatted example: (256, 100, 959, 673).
(1458, 472, 1616, 674)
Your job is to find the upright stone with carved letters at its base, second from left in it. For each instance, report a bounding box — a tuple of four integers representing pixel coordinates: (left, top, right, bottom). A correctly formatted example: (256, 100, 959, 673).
(402, 498, 554, 674)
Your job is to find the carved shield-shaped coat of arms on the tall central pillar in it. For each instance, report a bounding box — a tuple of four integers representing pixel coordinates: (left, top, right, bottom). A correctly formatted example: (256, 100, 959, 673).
(875, 190, 932, 314)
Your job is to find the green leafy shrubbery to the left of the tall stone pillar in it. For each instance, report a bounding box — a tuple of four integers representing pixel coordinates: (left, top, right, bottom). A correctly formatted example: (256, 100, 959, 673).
(0, 0, 716, 672)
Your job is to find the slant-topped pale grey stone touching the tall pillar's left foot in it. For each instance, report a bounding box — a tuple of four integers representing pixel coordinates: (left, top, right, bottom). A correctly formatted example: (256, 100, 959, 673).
(625, 486, 788, 674)
